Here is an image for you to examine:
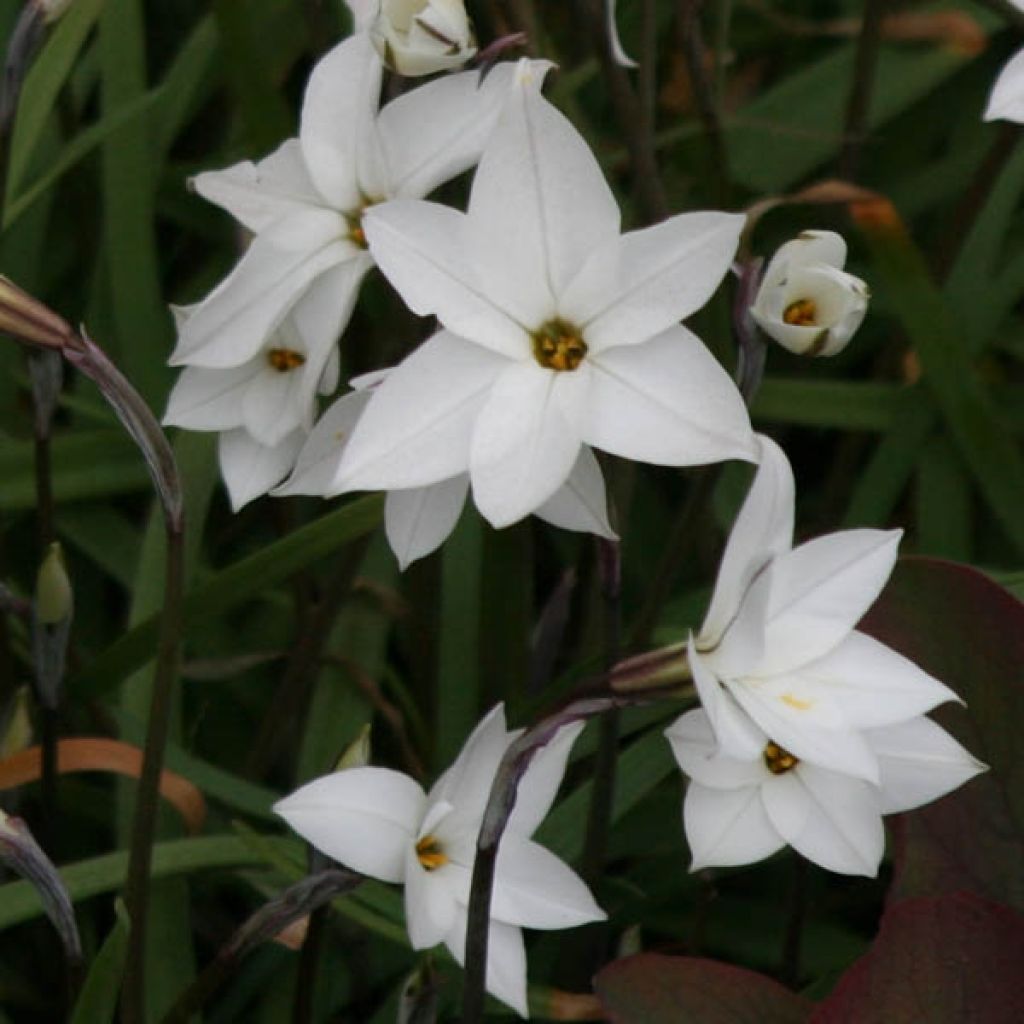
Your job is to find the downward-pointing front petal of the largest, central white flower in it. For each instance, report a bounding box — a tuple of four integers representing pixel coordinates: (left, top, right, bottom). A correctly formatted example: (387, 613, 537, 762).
(469, 362, 580, 527)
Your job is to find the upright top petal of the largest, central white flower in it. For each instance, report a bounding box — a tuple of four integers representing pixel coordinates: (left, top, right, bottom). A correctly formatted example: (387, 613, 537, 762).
(469, 63, 620, 303)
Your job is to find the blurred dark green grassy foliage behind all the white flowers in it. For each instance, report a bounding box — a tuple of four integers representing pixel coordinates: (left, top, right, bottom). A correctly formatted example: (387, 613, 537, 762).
(0, 0, 1024, 1022)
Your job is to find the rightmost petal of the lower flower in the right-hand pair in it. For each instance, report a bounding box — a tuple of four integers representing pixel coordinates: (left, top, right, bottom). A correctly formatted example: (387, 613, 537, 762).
(866, 717, 987, 814)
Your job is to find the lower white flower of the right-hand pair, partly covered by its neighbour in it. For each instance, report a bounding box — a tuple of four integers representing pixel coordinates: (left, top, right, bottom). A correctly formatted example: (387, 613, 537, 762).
(666, 711, 985, 876)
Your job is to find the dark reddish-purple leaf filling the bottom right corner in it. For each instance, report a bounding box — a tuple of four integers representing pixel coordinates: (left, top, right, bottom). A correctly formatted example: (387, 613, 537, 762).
(809, 892, 1024, 1024)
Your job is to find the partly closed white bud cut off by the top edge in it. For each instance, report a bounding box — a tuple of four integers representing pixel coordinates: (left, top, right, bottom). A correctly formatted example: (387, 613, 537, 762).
(370, 0, 476, 77)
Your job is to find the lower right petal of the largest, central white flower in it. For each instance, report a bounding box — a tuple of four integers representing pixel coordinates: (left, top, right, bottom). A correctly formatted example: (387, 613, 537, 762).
(583, 327, 757, 466)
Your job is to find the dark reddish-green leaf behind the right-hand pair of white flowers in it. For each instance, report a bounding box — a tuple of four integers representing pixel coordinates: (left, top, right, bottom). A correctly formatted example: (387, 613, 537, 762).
(860, 558, 1024, 908)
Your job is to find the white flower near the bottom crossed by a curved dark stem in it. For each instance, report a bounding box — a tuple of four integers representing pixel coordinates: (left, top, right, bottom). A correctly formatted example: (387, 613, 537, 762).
(274, 705, 604, 1017)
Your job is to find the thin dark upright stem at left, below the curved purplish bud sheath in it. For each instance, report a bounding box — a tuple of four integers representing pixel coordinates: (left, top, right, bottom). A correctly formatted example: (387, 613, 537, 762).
(121, 514, 184, 1024)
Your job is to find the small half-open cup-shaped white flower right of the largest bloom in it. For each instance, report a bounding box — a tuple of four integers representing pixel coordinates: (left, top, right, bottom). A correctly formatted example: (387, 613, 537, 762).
(751, 231, 870, 355)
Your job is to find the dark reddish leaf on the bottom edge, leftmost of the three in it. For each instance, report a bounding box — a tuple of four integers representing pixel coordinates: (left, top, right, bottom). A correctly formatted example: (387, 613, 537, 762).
(594, 953, 811, 1024)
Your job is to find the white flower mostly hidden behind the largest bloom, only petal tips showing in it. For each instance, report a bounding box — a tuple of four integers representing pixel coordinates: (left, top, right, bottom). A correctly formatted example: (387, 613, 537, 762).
(274, 372, 616, 569)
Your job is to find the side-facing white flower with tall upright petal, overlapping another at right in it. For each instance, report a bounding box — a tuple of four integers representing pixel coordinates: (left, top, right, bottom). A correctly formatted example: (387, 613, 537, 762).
(688, 435, 958, 783)
